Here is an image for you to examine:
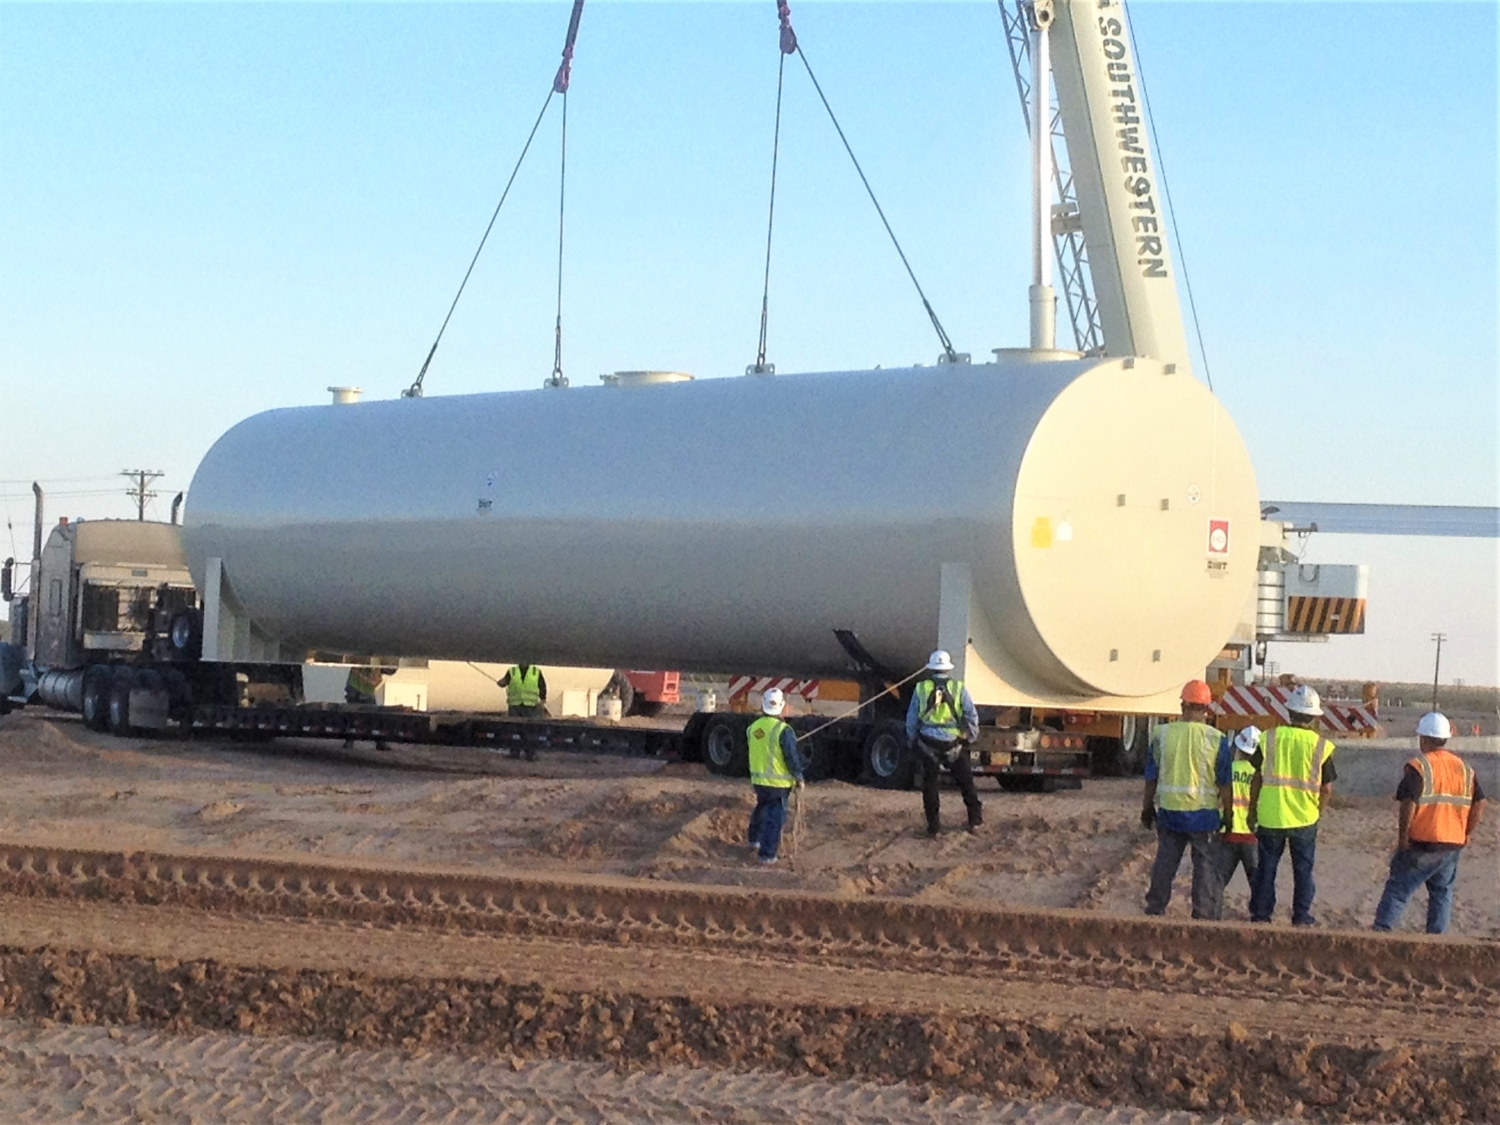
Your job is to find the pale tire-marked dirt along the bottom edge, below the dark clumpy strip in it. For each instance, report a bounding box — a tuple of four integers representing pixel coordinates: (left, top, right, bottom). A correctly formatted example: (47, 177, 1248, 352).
(0, 1020, 1248, 1125)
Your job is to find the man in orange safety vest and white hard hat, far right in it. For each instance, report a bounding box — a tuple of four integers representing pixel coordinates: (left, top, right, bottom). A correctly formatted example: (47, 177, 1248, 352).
(1376, 711, 1485, 933)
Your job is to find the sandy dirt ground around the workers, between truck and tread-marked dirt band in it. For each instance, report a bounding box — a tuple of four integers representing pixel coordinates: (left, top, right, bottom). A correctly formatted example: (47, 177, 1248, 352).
(0, 711, 1500, 938)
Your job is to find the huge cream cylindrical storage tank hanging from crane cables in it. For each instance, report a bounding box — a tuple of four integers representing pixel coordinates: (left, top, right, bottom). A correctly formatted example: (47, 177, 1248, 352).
(183, 360, 1259, 702)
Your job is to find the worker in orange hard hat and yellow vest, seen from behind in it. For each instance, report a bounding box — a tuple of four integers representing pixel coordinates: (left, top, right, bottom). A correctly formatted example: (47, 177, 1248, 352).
(1140, 680, 1229, 921)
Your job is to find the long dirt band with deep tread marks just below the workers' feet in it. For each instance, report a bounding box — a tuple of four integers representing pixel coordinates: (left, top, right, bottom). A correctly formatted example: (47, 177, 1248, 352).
(0, 845, 1500, 1017)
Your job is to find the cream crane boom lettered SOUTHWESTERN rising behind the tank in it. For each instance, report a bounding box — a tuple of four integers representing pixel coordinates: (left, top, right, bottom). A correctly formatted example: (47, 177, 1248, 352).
(1037, 0, 1193, 374)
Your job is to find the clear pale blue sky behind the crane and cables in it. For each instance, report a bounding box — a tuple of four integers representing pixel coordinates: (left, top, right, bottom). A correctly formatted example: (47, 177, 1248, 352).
(0, 0, 1500, 683)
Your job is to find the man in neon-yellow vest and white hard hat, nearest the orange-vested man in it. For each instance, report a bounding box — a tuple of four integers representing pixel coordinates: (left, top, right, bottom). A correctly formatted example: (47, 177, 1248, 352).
(1250, 686, 1338, 926)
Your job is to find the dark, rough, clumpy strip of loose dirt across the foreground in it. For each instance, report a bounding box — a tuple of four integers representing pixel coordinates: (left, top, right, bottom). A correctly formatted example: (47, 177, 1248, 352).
(0, 935, 1500, 1122)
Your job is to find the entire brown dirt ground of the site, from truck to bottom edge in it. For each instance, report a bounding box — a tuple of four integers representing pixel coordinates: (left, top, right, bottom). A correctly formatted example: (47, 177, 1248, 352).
(0, 710, 1500, 1122)
